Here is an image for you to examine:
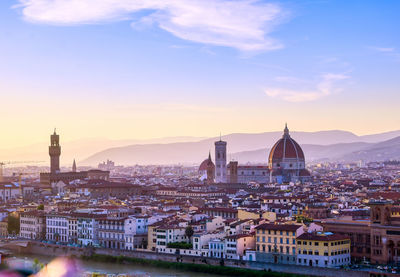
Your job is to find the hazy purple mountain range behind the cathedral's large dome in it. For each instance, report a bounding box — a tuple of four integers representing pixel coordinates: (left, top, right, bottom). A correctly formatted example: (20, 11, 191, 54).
(79, 130, 400, 165)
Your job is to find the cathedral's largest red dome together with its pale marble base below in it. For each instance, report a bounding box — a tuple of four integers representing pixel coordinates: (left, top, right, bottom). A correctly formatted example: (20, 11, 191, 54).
(268, 125, 311, 183)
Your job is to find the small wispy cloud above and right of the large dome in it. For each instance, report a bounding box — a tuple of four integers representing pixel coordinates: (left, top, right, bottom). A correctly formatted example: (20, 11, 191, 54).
(265, 73, 349, 102)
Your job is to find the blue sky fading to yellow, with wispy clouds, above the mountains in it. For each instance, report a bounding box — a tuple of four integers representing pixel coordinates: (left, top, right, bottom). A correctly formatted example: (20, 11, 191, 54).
(0, 0, 400, 148)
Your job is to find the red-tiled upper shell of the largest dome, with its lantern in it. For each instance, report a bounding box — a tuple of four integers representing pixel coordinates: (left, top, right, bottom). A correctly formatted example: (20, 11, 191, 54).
(268, 127, 304, 164)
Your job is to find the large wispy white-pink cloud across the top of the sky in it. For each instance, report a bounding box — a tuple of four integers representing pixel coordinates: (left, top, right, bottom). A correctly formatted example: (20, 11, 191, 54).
(15, 0, 286, 51)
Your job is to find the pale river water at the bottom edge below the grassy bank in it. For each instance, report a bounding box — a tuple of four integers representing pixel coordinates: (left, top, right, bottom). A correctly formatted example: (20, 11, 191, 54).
(3, 252, 222, 277)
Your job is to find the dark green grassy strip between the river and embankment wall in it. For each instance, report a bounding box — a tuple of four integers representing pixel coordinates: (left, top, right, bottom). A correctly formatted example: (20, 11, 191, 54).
(81, 254, 306, 277)
